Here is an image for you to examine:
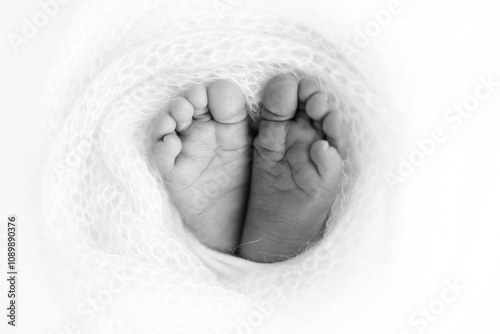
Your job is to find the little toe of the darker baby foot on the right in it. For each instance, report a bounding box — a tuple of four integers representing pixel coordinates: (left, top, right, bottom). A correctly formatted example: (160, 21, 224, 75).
(311, 140, 342, 184)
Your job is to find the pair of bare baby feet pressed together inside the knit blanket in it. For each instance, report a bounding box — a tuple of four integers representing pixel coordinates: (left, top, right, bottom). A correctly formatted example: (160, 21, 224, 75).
(154, 74, 347, 262)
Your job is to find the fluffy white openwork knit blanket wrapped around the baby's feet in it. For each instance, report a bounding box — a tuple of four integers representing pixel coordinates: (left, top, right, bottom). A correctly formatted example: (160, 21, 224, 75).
(44, 0, 391, 333)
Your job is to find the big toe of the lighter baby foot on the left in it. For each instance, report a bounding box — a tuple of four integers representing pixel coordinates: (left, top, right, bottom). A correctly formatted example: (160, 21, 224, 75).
(208, 80, 247, 124)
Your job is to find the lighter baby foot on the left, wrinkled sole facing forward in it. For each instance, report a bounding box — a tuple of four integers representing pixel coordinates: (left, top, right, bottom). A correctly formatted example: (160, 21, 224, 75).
(154, 80, 252, 252)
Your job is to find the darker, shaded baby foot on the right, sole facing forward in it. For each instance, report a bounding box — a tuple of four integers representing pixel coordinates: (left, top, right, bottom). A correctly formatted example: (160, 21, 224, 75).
(239, 75, 347, 262)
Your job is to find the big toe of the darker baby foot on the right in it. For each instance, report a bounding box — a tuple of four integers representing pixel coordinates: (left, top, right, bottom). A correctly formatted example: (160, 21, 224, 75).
(261, 74, 299, 121)
